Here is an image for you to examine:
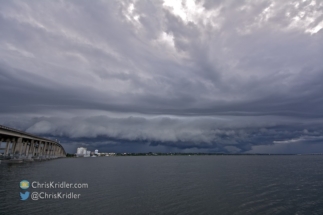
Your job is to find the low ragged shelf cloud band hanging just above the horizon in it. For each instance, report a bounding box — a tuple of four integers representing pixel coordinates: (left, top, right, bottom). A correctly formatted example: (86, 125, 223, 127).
(1, 116, 323, 152)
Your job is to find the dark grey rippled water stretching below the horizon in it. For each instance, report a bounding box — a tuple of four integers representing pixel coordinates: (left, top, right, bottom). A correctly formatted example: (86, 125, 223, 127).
(0, 156, 323, 215)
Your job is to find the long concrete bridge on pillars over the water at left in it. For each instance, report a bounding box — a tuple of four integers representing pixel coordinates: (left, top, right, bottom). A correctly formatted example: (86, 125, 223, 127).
(0, 125, 66, 163)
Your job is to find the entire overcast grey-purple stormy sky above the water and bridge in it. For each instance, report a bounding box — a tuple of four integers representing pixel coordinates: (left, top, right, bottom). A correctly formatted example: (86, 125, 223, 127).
(0, 0, 323, 153)
